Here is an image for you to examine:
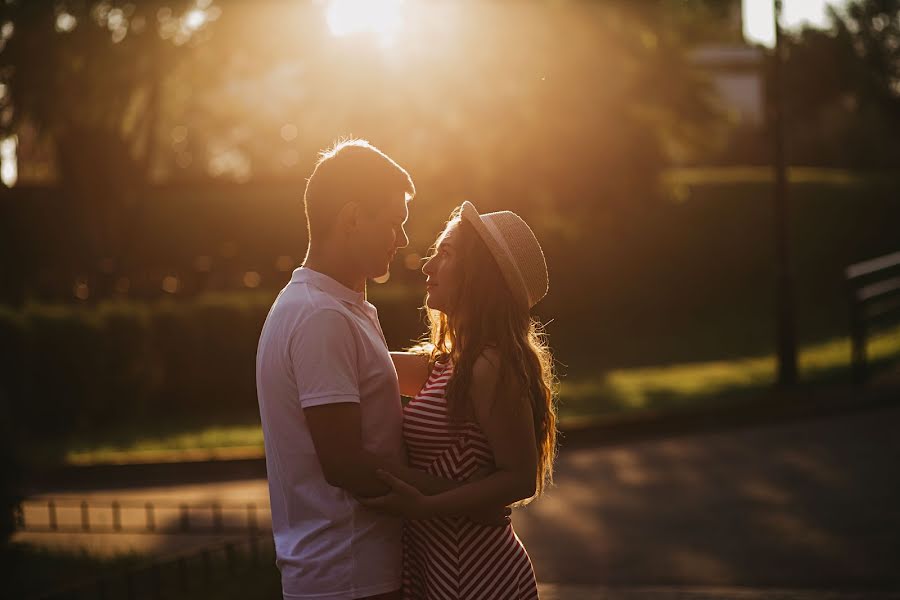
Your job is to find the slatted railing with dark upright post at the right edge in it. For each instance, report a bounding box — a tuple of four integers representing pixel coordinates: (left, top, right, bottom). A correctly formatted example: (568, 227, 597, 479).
(844, 252, 900, 383)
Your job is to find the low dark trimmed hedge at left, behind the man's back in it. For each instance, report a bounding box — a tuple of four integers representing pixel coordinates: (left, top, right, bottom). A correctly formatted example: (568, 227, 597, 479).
(0, 294, 428, 439)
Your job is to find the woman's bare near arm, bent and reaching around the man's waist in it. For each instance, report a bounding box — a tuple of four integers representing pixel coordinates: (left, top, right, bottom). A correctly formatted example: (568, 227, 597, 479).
(364, 351, 538, 518)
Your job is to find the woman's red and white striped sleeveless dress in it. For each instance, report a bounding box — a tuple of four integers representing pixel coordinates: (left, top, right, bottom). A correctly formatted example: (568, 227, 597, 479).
(403, 364, 538, 600)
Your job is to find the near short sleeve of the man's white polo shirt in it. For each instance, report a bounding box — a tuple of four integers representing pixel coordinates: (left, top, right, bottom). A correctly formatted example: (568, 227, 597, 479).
(290, 309, 359, 408)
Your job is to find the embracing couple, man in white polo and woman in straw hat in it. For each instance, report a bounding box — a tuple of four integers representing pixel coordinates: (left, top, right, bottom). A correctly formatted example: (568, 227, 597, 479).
(256, 140, 556, 600)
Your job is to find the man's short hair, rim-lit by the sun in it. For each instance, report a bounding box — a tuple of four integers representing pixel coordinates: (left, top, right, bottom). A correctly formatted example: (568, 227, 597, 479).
(303, 139, 416, 239)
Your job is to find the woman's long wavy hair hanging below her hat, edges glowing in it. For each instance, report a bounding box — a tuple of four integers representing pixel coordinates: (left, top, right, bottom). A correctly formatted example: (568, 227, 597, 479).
(413, 208, 557, 504)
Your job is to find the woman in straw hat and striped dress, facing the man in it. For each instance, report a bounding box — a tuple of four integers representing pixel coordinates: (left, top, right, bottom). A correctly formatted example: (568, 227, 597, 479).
(362, 202, 556, 599)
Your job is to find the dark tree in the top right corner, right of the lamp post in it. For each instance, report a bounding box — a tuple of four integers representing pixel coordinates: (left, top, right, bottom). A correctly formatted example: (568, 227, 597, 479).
(772, 0, 900, 168)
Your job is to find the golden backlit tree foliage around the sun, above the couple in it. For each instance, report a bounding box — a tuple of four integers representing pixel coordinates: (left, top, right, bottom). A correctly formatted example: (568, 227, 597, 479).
(0, 0, 719, 297)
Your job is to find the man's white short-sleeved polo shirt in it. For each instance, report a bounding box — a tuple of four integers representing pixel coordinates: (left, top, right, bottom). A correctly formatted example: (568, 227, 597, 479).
(256, 267, 406, 600)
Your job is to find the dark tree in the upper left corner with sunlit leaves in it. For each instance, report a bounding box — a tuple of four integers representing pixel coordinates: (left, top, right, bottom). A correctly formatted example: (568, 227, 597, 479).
(0, 0, 218, 296)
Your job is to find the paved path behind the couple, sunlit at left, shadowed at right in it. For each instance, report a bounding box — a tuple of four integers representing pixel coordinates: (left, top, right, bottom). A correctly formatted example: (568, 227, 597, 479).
(18, 398, 900, 600)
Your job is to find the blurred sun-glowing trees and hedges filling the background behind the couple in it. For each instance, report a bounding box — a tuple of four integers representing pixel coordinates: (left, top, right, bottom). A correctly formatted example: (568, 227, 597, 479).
(0, 0, 900, 464)
